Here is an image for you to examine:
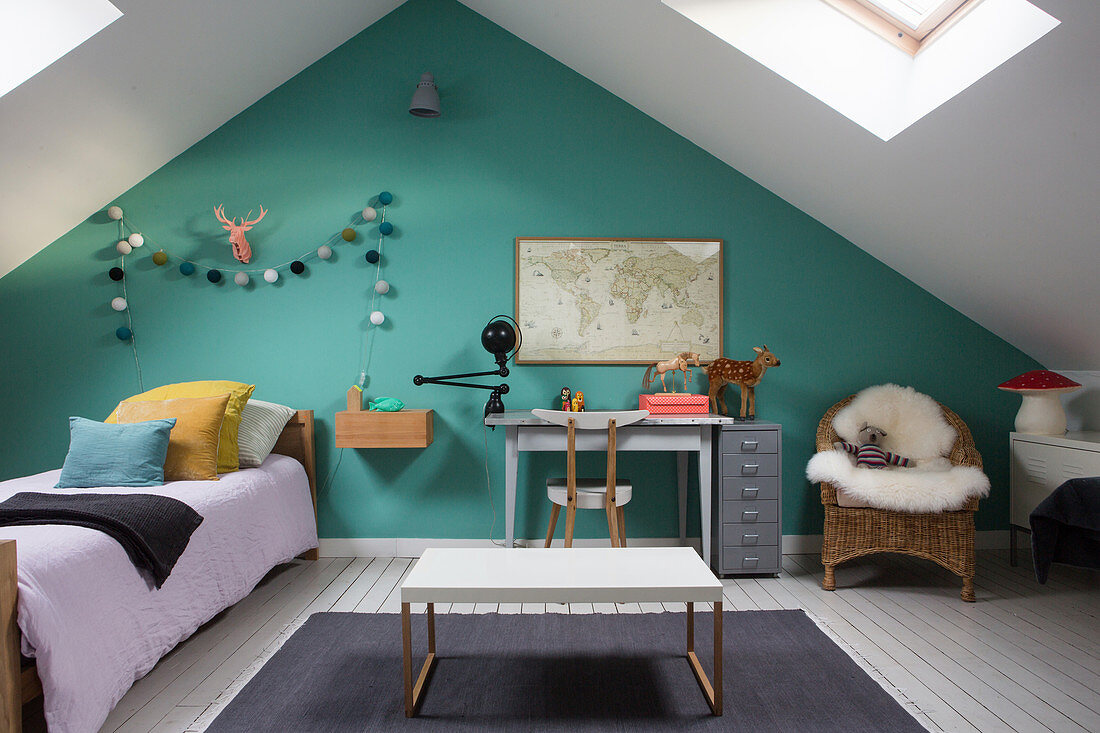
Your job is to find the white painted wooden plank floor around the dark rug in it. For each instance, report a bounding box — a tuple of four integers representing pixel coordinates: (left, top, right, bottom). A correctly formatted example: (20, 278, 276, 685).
(81, 550, 1100, 733)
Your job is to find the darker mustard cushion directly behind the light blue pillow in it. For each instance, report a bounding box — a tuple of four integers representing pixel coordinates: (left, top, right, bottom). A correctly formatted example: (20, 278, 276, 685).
(116, 394, 229, 481)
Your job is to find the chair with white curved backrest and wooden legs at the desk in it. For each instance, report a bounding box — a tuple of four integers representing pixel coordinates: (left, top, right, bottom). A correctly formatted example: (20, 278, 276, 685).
(531, 409, 649, 547)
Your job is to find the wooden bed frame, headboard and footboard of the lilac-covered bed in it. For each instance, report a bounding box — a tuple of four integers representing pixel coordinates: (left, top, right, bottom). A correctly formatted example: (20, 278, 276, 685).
(0, 409, 318, 731)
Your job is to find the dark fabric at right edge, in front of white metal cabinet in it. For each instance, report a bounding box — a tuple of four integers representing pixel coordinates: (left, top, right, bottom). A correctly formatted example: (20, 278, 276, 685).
(1031, 477, 1100, 583)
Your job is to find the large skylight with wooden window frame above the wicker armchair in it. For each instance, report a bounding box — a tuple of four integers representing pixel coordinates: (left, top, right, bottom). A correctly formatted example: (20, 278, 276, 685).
(662, 0, 1058, 140)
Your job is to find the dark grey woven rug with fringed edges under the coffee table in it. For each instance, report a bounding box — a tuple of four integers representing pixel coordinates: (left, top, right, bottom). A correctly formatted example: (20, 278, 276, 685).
(208, 611, 924, 733)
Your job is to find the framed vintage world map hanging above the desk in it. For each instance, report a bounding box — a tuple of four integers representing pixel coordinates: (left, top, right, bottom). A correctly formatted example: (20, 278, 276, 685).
(516, 237, 723, 364)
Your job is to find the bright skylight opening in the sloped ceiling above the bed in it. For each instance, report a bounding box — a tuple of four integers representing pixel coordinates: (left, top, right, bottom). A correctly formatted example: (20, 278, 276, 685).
(0, 0, 122, 97)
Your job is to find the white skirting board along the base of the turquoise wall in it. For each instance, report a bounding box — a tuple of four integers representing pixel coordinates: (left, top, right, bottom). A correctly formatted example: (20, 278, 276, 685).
(320, 529, 1009, 557)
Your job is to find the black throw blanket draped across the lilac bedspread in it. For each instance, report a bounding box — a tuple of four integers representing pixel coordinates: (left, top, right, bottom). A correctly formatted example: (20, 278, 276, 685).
(0, 492, 202, 588)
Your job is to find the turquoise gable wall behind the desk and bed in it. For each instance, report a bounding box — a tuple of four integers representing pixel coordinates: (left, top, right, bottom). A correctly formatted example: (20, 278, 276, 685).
(0, 0, 1036, 538)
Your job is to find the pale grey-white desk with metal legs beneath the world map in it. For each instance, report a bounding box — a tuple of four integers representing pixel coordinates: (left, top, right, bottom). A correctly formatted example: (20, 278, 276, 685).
(485, 409, 735, 559)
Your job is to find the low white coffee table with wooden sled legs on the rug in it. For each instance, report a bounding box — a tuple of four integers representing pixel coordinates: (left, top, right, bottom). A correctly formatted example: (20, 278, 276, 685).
(402, 547, 722, 718)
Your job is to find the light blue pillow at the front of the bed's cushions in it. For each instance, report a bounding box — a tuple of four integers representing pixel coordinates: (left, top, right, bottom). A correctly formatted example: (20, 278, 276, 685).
(54, 417, 176, 489)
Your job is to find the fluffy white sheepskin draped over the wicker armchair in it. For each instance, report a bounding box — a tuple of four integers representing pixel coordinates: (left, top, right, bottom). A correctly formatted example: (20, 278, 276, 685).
(806, 384, 989, 514)
